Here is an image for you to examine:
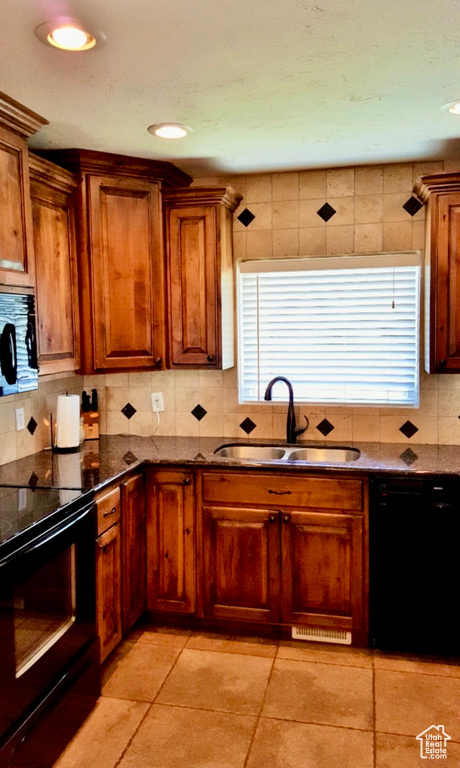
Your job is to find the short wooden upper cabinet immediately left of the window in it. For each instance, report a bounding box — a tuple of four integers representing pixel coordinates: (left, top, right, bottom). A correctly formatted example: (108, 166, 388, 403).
(163, 187, 242, 368)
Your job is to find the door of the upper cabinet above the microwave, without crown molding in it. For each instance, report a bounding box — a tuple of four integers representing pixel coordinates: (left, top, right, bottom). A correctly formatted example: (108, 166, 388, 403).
(0, 126, 35, 286)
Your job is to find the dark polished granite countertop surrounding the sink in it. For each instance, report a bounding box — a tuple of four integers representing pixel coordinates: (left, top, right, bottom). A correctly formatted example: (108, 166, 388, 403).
(0, 435, 460, 490)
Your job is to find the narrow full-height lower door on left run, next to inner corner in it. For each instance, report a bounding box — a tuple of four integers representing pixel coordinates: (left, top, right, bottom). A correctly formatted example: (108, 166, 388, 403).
(121, 475, 146, 634)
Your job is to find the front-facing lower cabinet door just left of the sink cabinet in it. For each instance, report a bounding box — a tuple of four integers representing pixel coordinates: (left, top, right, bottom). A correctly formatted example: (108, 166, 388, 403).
(147, 470, 196, 613)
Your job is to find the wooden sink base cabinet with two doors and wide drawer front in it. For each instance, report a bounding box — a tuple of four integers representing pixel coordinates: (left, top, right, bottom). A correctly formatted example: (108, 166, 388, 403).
(202, 472, 367, 644)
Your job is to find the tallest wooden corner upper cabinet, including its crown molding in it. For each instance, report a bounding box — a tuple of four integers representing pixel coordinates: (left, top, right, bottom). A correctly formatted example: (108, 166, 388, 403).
(39, 149, 191, 373)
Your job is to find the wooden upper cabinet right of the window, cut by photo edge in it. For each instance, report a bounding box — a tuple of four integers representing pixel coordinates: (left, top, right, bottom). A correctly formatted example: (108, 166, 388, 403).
(414, 173, 460, 373)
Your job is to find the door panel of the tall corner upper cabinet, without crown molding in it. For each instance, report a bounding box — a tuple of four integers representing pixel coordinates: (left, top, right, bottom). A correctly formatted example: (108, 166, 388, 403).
(83, 175, 165, 371)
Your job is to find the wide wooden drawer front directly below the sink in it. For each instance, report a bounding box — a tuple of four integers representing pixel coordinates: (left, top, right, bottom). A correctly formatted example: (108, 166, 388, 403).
(203, 472, 364, 512)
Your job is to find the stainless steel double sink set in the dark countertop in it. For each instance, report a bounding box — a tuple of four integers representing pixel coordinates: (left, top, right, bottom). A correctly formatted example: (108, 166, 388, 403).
(214, 443, 360, 464)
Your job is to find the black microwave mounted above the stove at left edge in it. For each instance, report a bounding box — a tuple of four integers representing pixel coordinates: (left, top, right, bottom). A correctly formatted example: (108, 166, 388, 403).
(0, 286, 38, 396)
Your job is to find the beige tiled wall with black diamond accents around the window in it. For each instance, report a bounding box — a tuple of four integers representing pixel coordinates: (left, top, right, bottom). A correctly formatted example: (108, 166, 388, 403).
(0, 162, 460, 463)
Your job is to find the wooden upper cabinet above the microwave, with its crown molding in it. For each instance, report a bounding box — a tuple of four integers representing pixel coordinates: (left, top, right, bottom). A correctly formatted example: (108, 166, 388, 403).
(0, 93, 48, 287)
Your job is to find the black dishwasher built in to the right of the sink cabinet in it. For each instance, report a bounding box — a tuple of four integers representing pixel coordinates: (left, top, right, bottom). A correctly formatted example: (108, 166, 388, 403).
(369, 476, 460, 656)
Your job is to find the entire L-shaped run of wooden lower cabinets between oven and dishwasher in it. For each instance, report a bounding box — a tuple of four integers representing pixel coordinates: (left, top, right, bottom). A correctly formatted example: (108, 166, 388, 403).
(96, 467, 368, 660)
